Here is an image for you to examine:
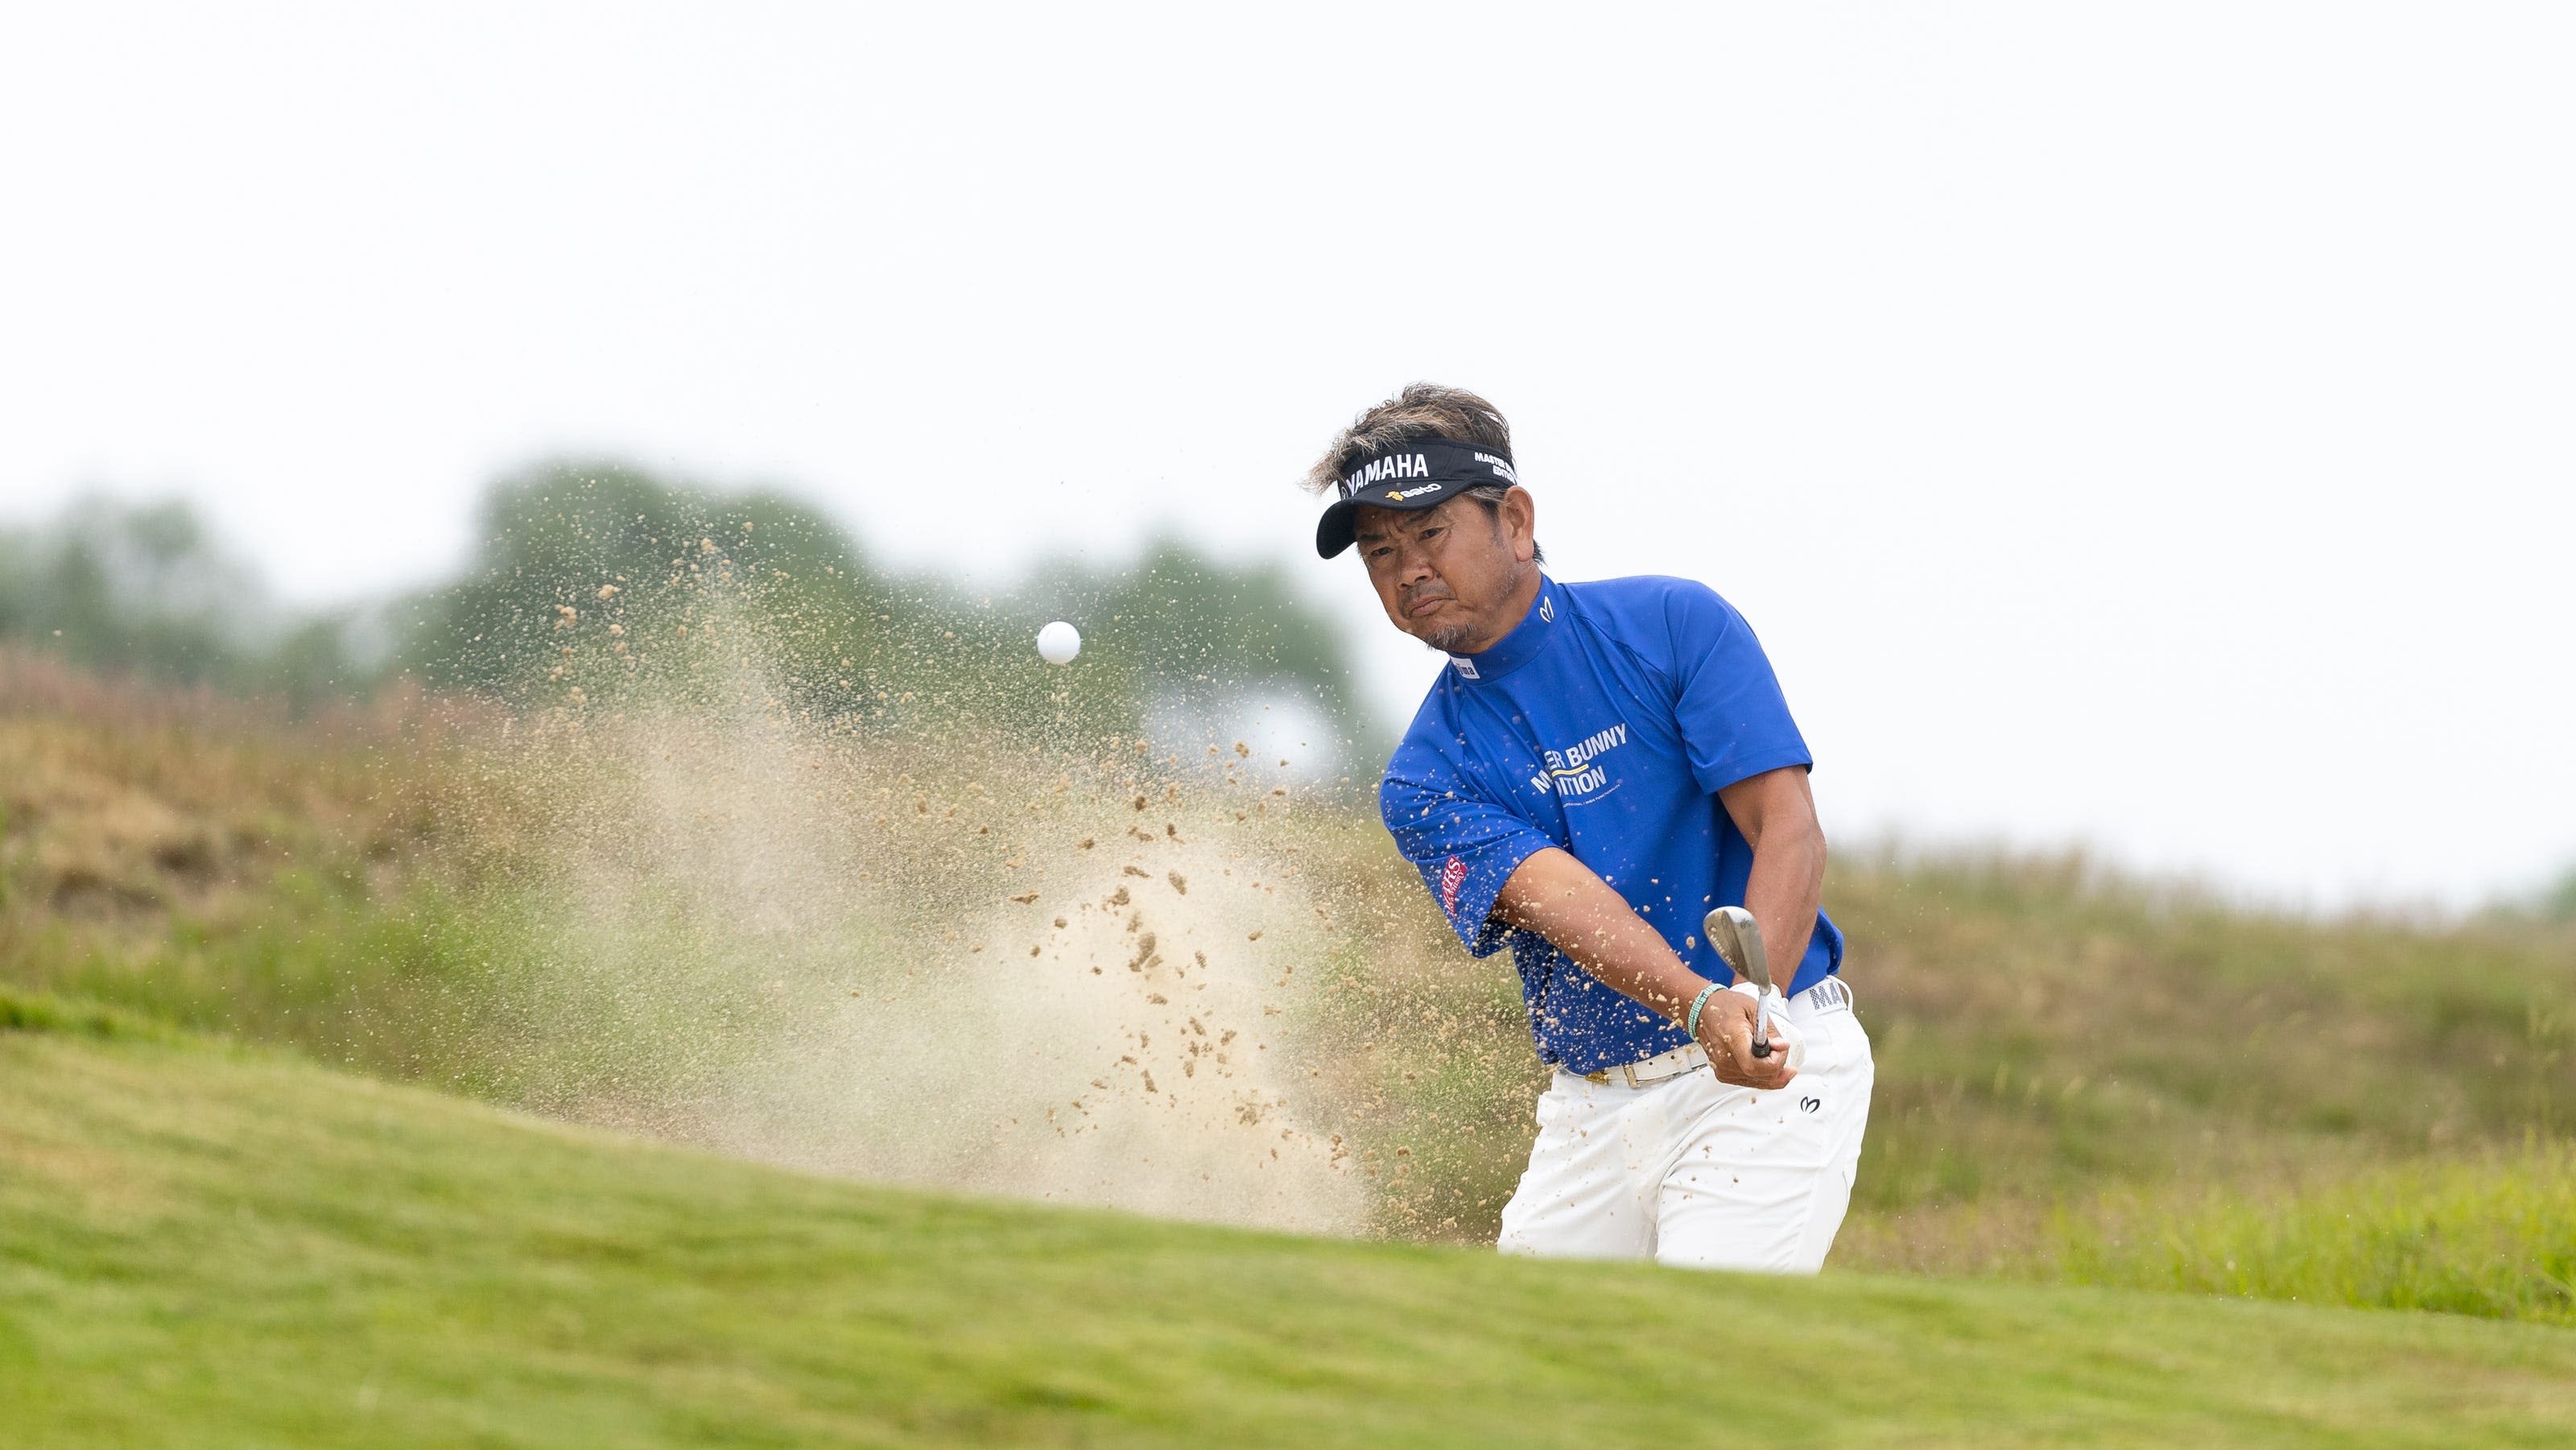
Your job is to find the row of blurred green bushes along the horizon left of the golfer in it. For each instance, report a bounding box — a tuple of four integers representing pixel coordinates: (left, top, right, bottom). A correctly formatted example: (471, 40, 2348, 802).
(0, 461, 1368, 762)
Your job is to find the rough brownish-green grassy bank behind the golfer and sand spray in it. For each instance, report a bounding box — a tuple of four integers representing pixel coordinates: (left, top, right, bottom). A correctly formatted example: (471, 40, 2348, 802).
(14, 651, 2576, 1321)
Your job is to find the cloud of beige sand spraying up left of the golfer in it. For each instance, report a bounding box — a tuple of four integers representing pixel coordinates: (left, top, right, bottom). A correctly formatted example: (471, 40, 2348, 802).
(448, 623, 1370, 1233)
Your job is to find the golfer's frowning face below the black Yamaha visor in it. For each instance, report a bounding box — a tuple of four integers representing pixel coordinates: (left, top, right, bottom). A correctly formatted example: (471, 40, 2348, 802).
(1352, 490, 1538, 655)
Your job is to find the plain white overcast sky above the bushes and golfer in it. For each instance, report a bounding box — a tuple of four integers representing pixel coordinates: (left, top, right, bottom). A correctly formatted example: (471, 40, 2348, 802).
(0, 2, 2576, 907)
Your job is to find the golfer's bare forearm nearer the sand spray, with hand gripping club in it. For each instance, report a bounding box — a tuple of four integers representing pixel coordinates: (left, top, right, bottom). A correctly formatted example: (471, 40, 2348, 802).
(1494, 847, 1803, 1092)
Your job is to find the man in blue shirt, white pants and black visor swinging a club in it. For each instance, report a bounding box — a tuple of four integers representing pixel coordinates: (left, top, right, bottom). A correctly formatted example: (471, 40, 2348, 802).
(1306, 384, 1872, 1272)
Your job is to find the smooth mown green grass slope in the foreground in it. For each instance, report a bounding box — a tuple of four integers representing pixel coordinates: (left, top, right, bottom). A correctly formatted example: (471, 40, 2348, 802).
(0, 1033, 2576, 1450)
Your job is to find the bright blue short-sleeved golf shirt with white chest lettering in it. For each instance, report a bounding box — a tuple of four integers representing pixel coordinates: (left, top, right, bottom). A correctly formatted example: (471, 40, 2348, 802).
(1378, 577, 1842, 1072)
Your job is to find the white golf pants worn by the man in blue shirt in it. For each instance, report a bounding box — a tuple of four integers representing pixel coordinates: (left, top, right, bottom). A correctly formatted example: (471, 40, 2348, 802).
(1499, 992, 1876, 1274)
